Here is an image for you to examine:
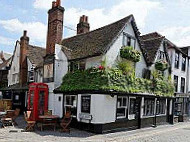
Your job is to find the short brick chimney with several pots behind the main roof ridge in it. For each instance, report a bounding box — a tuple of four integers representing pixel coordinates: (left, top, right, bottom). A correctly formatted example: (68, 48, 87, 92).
(77, 15, 90, 34)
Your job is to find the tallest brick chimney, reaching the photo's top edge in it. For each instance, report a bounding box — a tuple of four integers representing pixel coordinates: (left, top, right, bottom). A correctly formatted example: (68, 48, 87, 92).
(46, 0, 65, 55)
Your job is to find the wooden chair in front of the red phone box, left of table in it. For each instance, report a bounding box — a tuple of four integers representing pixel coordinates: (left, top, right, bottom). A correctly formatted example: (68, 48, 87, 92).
(24, 111, 36, 132)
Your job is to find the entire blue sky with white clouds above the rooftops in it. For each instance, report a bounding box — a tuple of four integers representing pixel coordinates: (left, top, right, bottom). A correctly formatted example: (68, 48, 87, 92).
(0, 0, 190, 53)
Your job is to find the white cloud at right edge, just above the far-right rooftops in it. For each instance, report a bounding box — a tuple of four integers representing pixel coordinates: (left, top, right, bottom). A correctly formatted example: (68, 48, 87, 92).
(159, 26, 190, 47)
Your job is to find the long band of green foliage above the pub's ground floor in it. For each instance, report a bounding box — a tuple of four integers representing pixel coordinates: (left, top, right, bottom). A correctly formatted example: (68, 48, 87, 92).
(61, 67, 174, 96)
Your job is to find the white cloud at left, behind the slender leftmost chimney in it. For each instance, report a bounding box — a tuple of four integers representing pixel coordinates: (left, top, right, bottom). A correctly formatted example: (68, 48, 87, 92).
(0, 19, 47, 43)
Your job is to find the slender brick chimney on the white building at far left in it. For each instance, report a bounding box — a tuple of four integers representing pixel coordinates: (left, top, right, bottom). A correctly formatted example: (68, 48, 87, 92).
(19, 31, 29, 86)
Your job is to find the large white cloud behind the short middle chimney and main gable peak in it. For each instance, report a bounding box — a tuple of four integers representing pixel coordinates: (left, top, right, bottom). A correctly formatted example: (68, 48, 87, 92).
(64, 0, 161, 37)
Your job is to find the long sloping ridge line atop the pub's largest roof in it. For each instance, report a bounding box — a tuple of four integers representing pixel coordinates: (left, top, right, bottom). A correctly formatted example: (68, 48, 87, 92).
(62, 14, 133, 41)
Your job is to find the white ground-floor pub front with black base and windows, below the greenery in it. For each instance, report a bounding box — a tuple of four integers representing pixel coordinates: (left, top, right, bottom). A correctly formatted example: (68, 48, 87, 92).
(55, 93, 174, 133)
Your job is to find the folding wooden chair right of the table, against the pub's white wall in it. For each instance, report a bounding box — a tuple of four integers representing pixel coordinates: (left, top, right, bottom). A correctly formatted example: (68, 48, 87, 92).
(60, 112, 72, 132)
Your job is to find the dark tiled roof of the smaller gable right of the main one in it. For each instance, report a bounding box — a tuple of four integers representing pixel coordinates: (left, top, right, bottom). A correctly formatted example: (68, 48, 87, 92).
(140, 32, 164, 65)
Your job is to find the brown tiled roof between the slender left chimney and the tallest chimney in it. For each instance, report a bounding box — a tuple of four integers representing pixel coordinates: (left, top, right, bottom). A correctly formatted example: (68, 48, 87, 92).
(27, 45, 46, 67)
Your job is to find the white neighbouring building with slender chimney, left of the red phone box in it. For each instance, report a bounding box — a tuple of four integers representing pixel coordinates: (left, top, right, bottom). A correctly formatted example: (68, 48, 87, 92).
(0, 31, 45, 111)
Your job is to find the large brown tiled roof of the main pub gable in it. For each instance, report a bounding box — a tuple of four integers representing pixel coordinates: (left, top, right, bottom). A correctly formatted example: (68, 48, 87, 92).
(62, 15, 139, 60)
